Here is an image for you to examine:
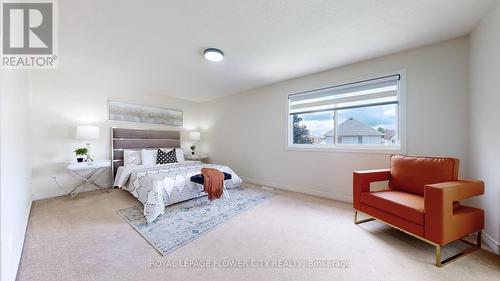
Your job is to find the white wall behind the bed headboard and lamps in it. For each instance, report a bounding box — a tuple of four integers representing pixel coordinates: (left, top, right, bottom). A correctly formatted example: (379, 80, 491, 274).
(30, 72, 199, 200)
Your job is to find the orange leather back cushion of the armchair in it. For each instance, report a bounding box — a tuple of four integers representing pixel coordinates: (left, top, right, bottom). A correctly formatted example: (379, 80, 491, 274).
(389, 155, 459, 196)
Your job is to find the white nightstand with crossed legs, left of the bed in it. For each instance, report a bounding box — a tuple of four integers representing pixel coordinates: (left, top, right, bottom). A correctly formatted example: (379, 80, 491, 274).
(66, 160, 111, 199)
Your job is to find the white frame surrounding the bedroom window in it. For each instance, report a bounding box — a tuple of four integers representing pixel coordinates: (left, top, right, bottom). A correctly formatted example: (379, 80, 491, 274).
(285, 70, 406, 154)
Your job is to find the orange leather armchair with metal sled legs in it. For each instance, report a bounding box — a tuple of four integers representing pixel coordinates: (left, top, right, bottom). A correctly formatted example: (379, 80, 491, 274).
(353, 155, 484, 267)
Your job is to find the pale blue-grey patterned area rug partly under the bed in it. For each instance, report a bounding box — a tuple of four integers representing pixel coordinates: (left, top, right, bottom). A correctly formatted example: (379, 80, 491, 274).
(118, 187, 275, 256)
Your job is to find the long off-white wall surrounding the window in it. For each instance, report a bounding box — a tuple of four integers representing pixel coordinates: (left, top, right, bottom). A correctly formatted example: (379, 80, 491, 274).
(200, 37, 468, 201)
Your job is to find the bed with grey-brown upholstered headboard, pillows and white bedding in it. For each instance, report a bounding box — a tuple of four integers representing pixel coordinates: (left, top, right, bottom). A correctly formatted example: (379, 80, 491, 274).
(111, 128, 242, 223)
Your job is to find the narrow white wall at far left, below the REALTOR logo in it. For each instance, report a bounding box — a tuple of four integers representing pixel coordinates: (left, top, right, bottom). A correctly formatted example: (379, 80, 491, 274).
(0, 71, 31, 281)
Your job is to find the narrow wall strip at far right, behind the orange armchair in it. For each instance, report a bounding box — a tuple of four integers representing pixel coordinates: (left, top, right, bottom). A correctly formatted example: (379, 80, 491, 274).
(469, 0, 500, 254)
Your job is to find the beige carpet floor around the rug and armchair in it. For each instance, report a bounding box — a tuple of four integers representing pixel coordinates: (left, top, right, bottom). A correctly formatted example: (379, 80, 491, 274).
(18, 184, 500, 281)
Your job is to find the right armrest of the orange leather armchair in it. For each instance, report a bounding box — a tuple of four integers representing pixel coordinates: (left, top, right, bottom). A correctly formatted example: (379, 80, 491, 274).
(424, 180, 484, 244)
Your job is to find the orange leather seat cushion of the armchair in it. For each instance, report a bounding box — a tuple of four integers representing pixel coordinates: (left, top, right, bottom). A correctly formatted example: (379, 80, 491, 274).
(361, 190, 425, 225)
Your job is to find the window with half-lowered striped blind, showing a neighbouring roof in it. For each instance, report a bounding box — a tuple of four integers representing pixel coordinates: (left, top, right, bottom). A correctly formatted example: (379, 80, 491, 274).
(288, 75, 400, 149)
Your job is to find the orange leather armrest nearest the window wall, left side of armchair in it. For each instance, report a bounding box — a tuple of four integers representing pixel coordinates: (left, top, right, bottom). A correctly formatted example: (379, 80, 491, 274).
(352, 169, 391, 209)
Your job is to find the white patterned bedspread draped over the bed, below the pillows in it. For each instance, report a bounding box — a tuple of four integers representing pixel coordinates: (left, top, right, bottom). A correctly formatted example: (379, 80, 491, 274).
(114, 161, 242, 223)
